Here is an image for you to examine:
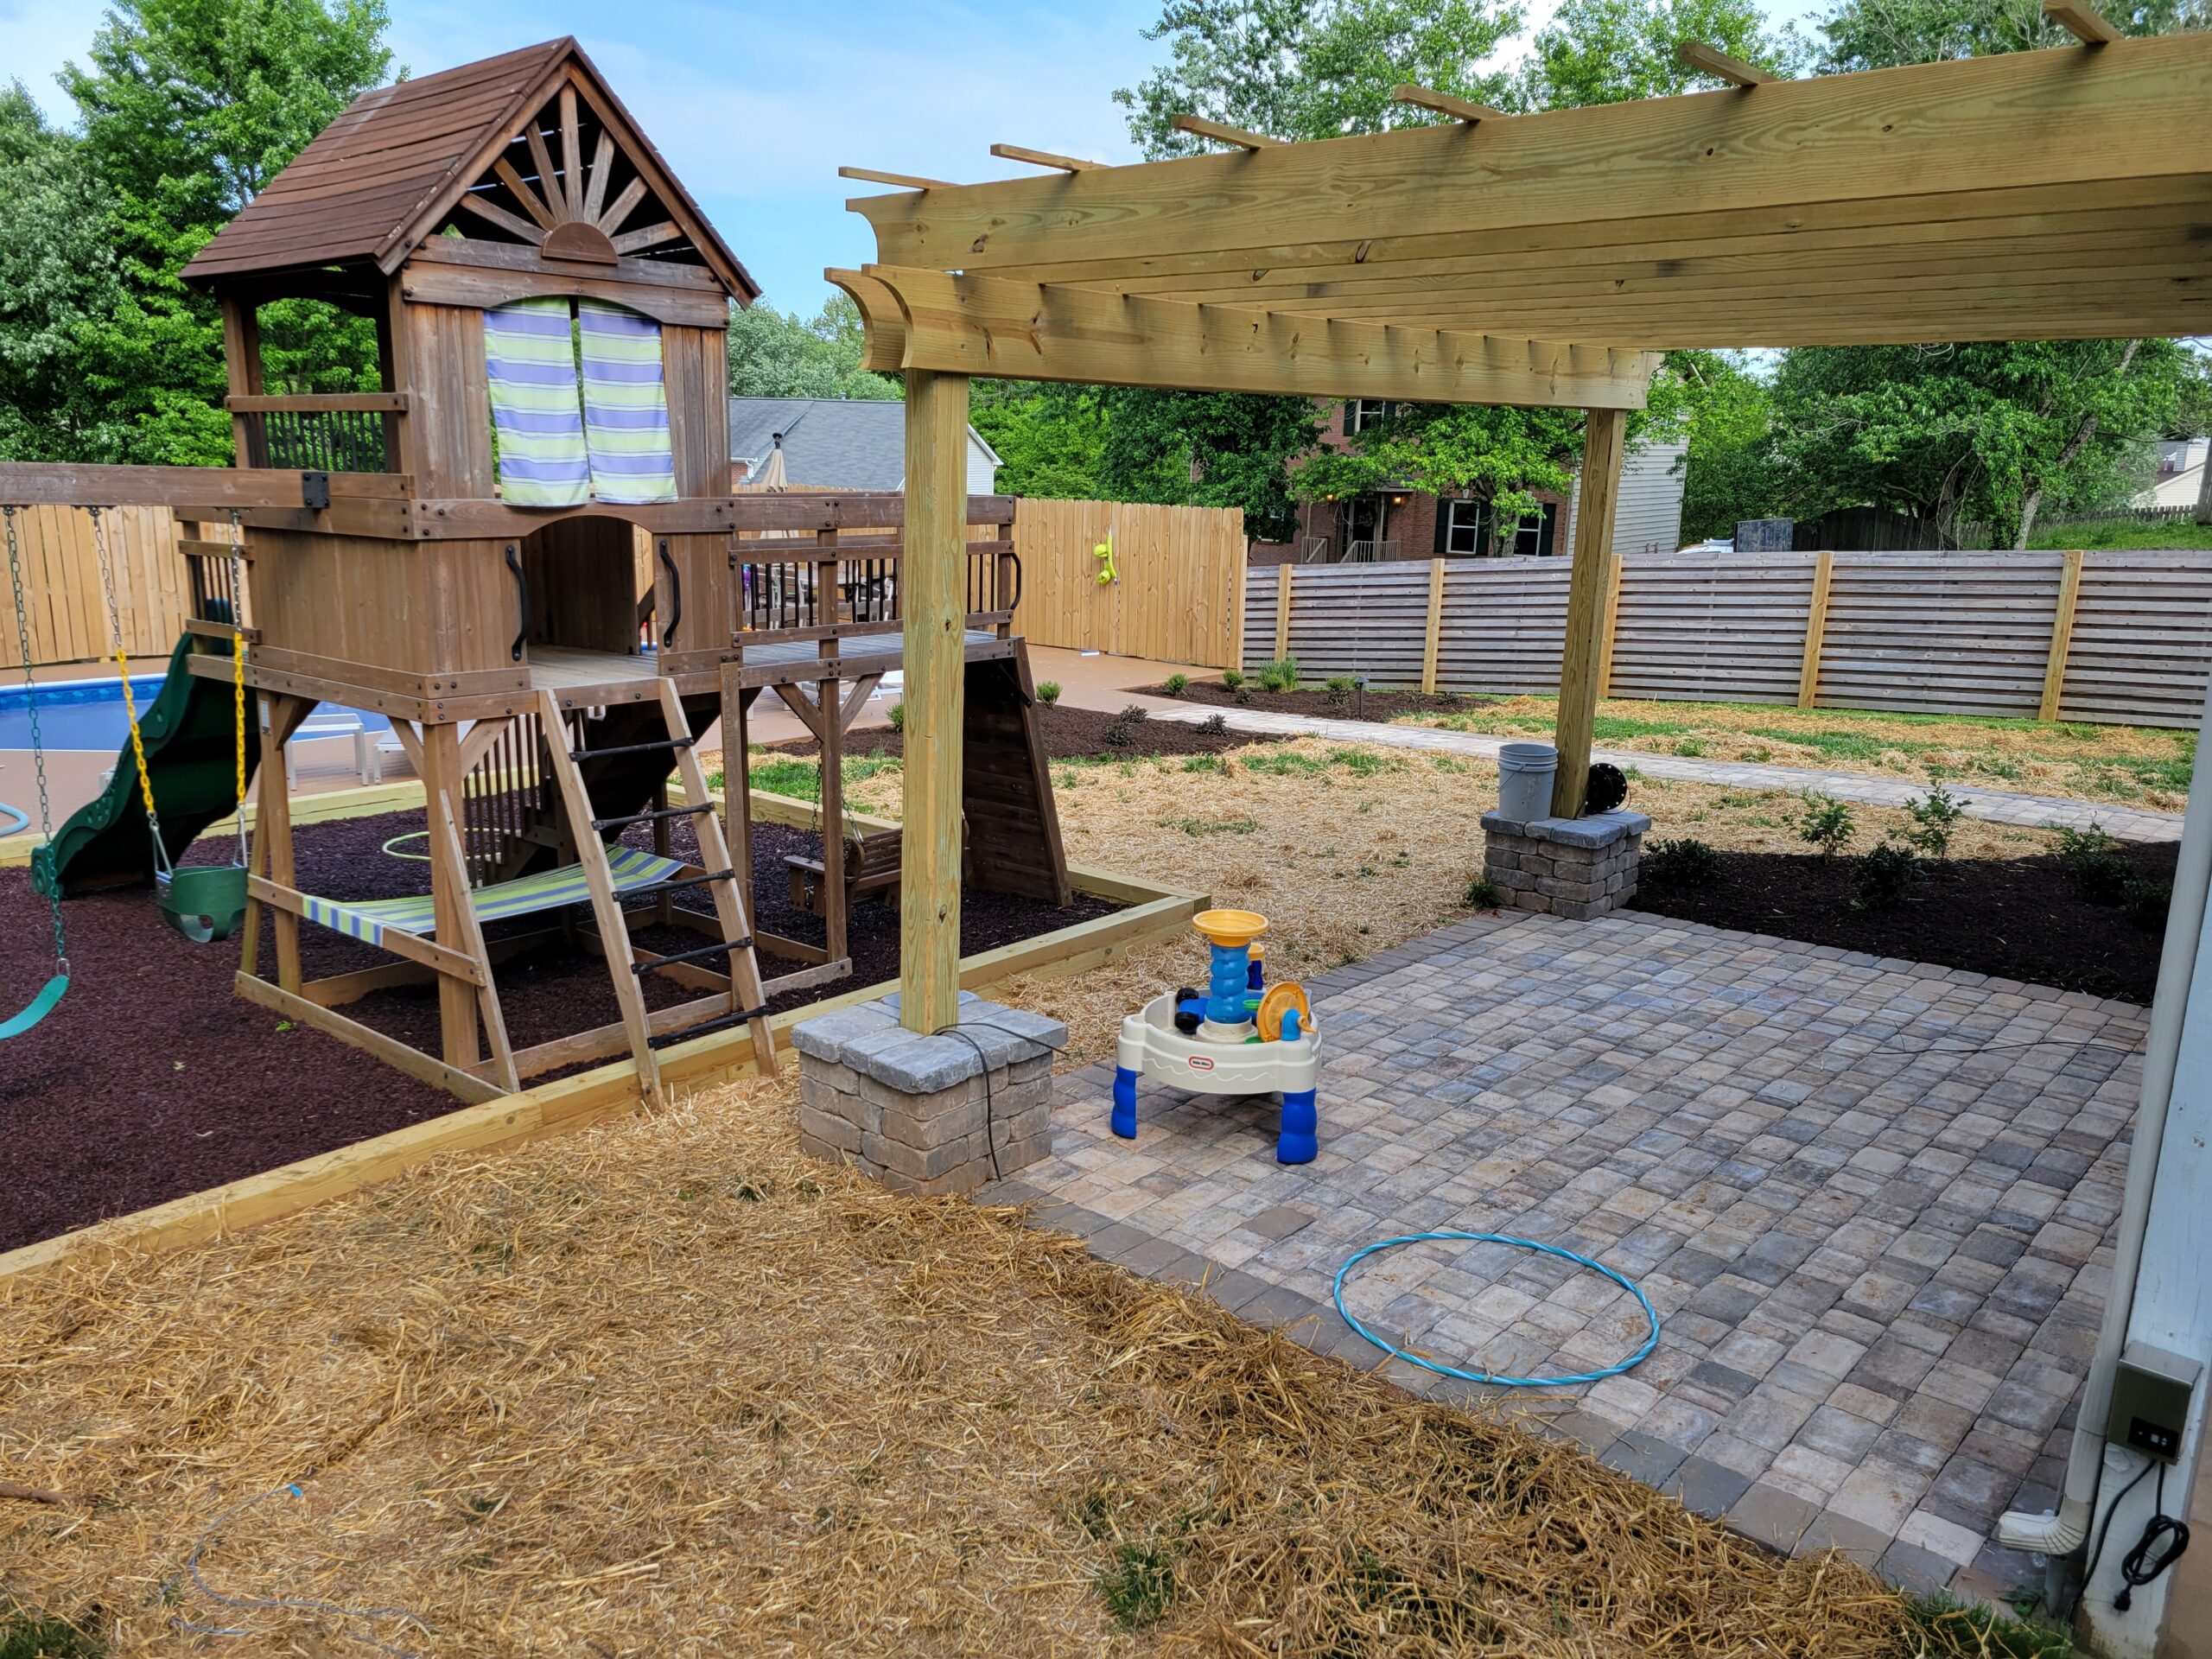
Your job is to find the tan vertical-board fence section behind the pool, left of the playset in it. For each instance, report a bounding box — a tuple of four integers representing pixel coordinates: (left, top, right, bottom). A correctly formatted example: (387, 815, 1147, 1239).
(0, 506, 193, 668)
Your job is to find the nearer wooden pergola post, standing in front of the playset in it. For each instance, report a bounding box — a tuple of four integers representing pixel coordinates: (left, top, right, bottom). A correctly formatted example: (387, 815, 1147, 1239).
(898, 370, 969, 1033)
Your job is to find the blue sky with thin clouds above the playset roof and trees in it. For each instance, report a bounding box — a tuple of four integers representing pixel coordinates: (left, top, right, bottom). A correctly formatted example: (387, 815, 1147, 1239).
(0, 0, 1812, 315)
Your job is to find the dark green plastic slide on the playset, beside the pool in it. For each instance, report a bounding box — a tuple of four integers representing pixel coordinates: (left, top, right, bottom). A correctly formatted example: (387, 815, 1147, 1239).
(31, 635, 261, 898)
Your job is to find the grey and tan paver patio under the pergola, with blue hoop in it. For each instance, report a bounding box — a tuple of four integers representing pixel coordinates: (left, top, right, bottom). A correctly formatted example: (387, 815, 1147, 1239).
(995, 912, 2145, 1595)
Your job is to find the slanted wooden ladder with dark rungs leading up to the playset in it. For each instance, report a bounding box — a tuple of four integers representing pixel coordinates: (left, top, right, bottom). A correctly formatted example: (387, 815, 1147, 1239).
(537, 675, 777, 1103)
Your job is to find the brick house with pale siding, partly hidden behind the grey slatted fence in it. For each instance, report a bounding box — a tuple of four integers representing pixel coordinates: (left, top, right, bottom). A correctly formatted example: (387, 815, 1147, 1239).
(1252, 398, 1688, 564)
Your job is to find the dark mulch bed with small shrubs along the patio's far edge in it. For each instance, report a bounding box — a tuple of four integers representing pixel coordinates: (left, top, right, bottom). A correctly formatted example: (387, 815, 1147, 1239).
(1632, 842, 2177, 1004)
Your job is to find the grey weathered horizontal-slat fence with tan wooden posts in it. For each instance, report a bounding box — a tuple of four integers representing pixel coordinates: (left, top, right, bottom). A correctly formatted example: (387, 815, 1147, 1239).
(1243, 549, 2212, 728)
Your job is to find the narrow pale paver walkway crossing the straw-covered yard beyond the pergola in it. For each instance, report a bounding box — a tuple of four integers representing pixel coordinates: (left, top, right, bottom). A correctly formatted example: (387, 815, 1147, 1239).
(1153, 702, 2181, 841)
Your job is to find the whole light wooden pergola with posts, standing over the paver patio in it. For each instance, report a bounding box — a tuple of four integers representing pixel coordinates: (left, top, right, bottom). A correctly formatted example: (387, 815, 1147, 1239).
(827, 22, 2212, 1031)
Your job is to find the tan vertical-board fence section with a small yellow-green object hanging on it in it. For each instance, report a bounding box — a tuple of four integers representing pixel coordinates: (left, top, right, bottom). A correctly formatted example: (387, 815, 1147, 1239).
(1013, 498, 1248, 668)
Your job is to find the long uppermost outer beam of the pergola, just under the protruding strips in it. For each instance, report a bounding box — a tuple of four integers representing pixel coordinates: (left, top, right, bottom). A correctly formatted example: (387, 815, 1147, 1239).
(861, 33, 2212, 343)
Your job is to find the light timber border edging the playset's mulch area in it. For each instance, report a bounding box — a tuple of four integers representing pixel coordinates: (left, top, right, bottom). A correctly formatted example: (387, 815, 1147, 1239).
(0, 783, 1208, 1285)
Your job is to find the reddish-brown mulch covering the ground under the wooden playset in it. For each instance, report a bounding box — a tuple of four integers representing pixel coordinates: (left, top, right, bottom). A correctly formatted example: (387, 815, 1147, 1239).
(0, 812, 1115, 1249)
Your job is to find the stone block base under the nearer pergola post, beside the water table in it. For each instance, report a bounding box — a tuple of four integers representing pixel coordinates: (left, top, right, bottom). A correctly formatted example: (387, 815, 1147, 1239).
(791, 991, 1068, 1197)
